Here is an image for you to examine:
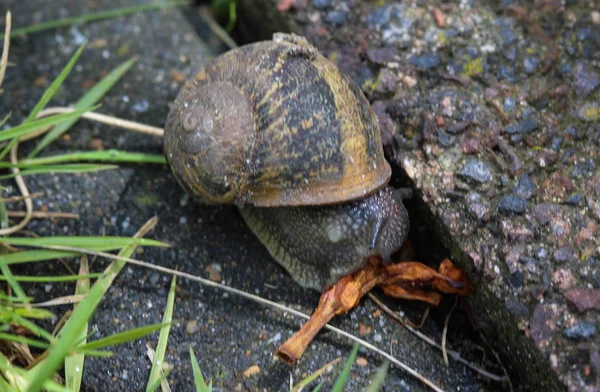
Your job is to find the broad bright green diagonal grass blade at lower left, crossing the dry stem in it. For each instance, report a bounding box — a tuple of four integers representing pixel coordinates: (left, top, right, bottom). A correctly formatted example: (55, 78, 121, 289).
(26, 220, 162, 392)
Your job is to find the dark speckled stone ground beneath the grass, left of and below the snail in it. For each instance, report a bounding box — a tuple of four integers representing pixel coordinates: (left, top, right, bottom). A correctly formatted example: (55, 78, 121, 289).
(0, 0, 492, 391)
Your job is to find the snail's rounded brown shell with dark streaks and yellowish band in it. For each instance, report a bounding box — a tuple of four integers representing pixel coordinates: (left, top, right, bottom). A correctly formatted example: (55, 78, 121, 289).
(164, 34, 391, 207)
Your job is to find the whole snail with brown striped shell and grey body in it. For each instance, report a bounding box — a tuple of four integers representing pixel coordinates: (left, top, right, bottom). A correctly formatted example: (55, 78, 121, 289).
(164, 33, 474, 362)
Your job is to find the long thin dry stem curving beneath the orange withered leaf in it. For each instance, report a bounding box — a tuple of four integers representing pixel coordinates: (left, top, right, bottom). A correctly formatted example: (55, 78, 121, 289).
(23, 245, 446, 392)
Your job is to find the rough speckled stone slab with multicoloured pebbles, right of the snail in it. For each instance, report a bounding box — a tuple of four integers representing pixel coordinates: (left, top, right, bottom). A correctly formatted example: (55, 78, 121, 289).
(236, 0, 600, 391)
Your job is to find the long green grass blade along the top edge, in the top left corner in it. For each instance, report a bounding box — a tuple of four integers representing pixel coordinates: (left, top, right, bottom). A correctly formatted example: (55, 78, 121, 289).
(0, 0, 189, 39)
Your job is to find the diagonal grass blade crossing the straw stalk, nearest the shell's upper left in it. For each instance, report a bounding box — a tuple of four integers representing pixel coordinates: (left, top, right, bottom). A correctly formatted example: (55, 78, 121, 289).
(27, 58, 136, 159)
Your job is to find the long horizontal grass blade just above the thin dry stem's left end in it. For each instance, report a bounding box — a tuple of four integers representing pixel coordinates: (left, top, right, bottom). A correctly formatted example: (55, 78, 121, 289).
(0, 236, 169, 248)
